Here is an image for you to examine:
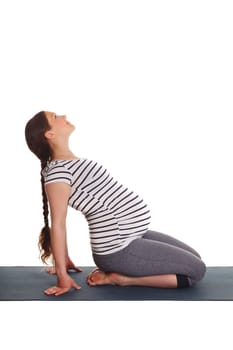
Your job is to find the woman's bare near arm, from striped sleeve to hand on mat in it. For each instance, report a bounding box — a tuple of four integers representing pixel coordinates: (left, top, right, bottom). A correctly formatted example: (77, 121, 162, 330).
(45, 182, 80, 295)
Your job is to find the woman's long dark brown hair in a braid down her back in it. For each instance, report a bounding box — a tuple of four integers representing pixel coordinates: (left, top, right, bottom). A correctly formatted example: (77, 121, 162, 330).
(25, 111, 52, 263)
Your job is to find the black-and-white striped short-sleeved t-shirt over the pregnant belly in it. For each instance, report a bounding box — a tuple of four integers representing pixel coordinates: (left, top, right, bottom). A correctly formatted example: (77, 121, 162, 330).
(43, 158, 150, 255)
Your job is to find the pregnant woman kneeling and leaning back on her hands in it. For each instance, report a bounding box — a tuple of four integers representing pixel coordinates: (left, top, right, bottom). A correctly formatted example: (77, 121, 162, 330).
(25, 111, 206, 295)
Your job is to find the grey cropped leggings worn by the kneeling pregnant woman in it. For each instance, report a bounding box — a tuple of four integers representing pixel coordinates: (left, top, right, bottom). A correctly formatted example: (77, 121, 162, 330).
(93, 230, 206, 285)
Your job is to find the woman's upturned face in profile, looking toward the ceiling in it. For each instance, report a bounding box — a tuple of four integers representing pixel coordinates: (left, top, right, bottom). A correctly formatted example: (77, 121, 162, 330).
(45, 112, 75, 135)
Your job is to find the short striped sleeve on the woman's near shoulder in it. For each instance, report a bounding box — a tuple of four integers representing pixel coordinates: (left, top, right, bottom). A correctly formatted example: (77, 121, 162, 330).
(43, 162, 72, 186)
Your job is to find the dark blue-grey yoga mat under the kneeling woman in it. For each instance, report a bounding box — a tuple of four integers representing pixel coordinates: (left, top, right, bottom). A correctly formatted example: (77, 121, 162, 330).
(0, 266, 233, 301)
